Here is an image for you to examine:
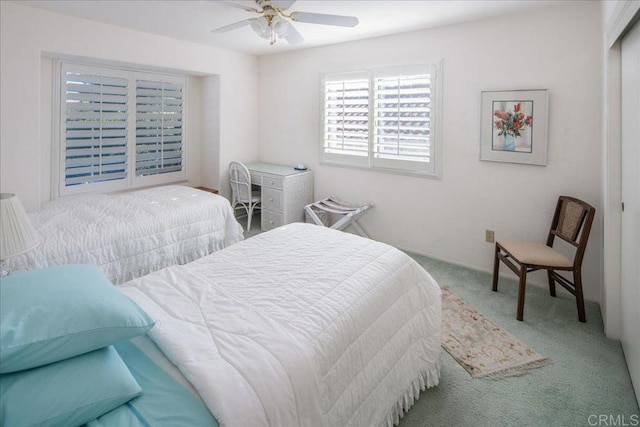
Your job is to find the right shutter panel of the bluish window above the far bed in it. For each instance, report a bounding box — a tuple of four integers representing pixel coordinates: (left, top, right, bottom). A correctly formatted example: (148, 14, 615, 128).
(136, 80, 183, 176)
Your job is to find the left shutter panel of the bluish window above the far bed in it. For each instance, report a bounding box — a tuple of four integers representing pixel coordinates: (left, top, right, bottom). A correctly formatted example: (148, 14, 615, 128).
(64, 71, 128, 187)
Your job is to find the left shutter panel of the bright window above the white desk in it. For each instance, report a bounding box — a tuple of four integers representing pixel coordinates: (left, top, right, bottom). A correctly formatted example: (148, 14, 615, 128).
(323, 73, 369, 166)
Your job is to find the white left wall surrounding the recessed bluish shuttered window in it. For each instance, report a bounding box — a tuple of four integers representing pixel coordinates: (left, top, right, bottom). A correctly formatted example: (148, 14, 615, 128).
(0, 2, 258, 210)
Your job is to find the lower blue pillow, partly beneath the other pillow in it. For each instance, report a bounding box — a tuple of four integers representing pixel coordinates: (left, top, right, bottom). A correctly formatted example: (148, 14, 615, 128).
(0, 346, 142, 426)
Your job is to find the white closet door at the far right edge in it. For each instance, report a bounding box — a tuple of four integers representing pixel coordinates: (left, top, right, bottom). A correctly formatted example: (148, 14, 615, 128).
(621, 18, 640, 400)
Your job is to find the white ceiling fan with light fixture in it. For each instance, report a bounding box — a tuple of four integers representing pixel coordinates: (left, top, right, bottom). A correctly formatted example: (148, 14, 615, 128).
(212, 0, 358, 45)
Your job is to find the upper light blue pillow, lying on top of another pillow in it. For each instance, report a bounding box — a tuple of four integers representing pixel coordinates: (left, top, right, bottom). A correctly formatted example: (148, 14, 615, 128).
(0, 265, 154, 374)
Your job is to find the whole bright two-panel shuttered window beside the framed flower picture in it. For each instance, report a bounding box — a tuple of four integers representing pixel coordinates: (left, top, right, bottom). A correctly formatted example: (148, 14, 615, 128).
(322, 64, 440, 177)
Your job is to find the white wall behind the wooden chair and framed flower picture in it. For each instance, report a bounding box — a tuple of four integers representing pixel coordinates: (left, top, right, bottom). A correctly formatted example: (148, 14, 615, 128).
(259, 2, 603, 301)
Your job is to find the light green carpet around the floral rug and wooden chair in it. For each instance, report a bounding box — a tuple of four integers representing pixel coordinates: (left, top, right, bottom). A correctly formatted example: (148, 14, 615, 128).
(400, 254, 640, 427)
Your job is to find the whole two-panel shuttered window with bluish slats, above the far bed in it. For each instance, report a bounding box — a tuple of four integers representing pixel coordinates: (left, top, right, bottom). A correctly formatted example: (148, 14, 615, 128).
(54, 63, 186, 196)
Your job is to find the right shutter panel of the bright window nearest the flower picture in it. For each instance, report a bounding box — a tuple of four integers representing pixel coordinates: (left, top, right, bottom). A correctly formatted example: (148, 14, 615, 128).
(372, 67, 432, 169)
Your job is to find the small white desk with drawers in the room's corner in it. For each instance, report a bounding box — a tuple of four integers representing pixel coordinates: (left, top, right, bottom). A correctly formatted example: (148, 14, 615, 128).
(247, 163, 313, 231)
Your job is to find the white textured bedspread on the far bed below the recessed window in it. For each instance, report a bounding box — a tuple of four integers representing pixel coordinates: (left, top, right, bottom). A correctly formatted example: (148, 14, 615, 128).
(7, 185, 243, 283)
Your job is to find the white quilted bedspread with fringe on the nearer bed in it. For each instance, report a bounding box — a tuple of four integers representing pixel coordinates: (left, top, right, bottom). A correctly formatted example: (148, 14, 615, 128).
(120, 224, 441, 426)
